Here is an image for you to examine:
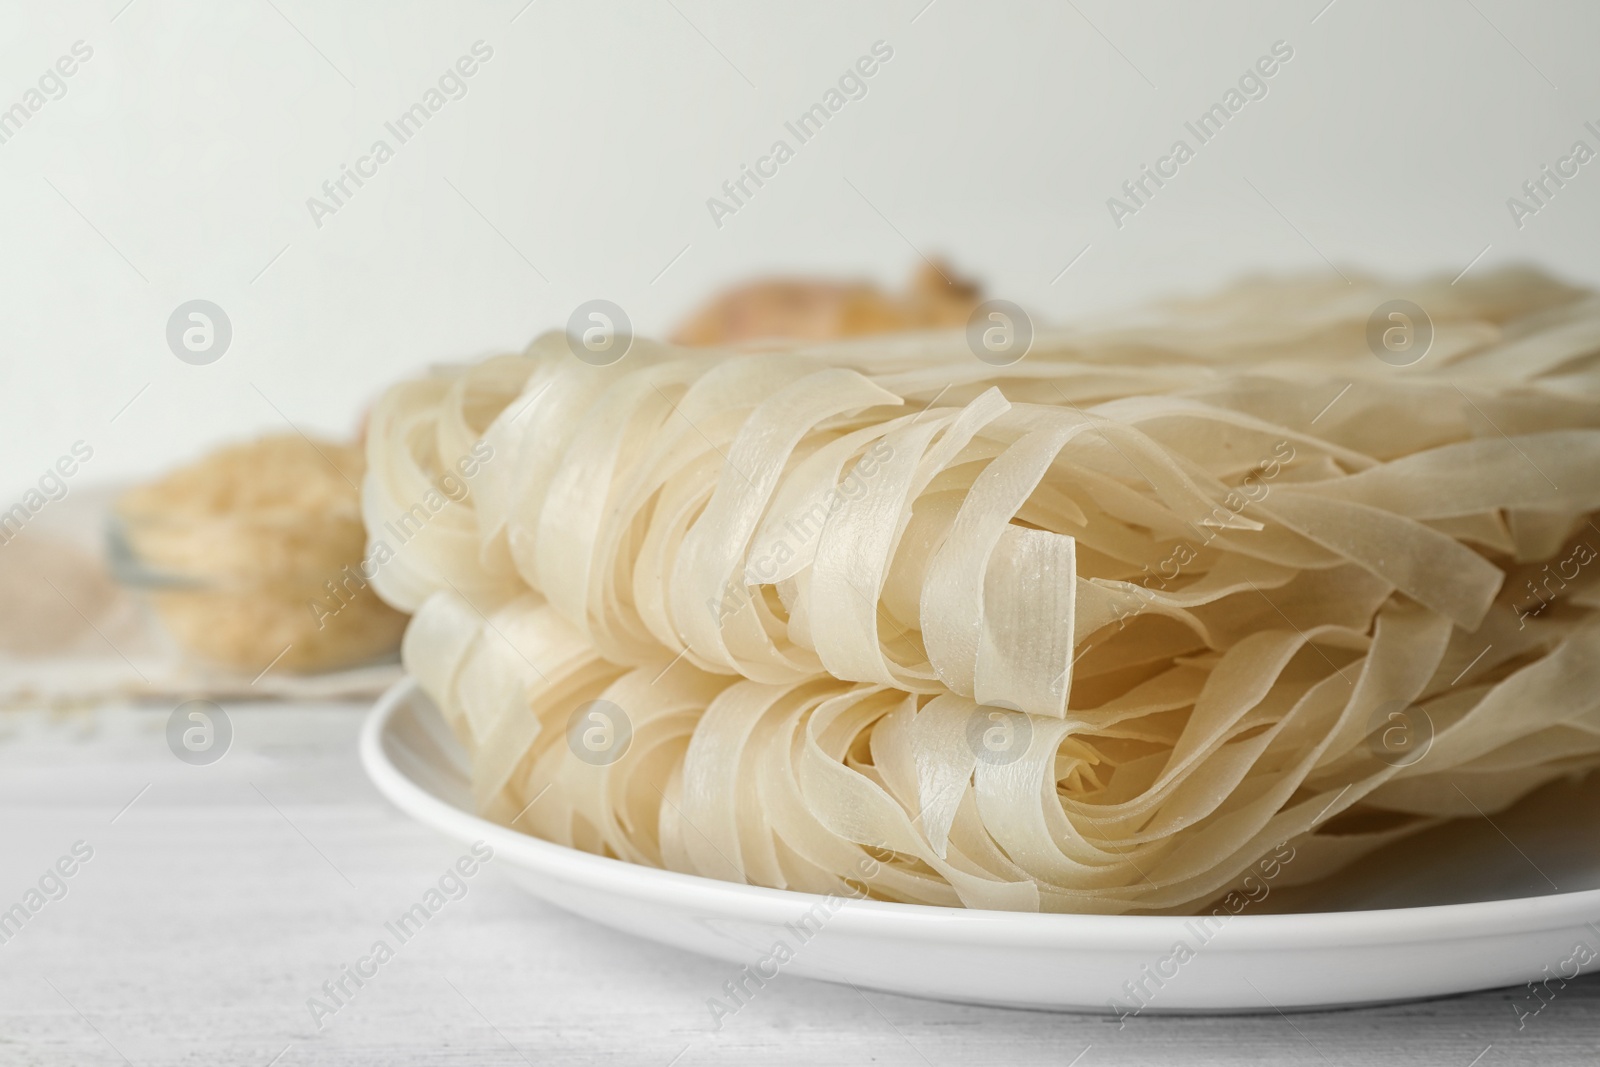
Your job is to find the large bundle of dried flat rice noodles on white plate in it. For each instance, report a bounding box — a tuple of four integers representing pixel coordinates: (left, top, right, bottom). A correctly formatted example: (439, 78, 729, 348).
(363, 274, 1600, 913)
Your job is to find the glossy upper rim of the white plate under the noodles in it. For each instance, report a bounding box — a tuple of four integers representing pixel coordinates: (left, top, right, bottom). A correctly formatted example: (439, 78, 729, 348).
(358, 673, 1600, 952)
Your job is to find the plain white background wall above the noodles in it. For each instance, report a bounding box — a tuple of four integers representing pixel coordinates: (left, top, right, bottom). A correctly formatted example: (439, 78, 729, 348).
(0, 0, 1600, 504)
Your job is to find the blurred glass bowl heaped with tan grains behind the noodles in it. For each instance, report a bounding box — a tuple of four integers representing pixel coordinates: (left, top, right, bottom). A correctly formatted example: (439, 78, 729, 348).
(115, 434, 406, 672)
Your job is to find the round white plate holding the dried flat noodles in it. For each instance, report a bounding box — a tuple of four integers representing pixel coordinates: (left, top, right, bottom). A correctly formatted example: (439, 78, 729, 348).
(362, 680, 1600, 1013)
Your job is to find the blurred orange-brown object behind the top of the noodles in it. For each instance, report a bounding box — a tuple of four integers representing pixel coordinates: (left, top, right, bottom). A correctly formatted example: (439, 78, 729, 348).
(672, 262, 979, 346)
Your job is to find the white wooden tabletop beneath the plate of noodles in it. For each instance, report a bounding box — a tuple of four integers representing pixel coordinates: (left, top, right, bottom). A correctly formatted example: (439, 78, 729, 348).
(0, 704, 1600, 1067)
